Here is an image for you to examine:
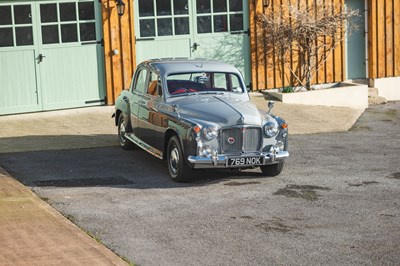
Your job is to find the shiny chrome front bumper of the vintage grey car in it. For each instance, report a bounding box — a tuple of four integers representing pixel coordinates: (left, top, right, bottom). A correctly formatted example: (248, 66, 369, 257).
(188, 151, 289, 168)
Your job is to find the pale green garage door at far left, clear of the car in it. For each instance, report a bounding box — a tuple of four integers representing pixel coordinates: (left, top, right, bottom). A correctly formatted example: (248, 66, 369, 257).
(0, 0, 105, 114)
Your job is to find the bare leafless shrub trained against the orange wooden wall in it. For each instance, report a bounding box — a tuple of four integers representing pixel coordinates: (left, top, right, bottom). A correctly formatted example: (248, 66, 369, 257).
(257, 0, 359, 90)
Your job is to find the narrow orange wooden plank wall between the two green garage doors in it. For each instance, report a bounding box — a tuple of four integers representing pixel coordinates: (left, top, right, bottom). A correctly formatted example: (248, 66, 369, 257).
(101, 0, 135, 105)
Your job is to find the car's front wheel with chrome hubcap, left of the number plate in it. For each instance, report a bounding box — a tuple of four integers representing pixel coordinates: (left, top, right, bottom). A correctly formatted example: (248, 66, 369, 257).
(167, 136, 193, 182)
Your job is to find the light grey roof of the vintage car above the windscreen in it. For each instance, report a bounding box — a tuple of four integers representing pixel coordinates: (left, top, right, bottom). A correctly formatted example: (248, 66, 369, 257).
(140, 58, 240, 76)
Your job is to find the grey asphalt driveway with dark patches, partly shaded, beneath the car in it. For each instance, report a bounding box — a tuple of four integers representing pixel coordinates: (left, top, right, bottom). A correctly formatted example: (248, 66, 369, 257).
(0, 102, 400, 265)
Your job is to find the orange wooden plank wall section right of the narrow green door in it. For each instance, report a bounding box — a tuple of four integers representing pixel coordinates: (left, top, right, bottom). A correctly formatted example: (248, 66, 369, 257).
(368, 0, 400, 78)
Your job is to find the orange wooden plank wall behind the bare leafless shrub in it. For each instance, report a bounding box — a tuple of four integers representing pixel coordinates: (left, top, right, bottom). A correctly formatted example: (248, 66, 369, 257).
(249, 0, 346, 90)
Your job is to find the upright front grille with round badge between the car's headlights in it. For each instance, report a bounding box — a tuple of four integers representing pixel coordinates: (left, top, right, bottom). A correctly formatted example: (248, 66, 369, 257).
(220, 127, 261, 154)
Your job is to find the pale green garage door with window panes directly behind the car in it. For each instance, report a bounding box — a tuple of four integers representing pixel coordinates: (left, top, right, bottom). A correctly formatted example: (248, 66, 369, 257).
(135, 0, 250, 83)
